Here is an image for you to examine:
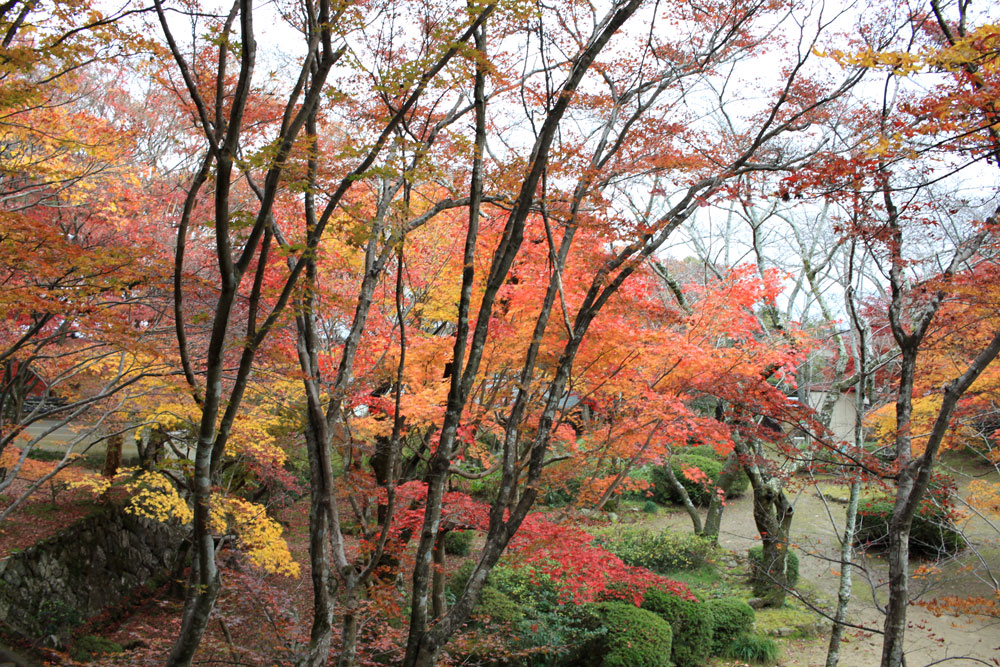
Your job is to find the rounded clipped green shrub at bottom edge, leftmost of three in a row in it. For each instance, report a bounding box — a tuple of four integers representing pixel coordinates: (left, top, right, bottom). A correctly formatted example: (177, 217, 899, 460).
(572, 602, 673, 667)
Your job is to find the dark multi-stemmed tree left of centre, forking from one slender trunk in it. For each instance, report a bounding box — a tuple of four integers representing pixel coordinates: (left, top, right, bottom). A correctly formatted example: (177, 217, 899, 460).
(156, 1, 491, 664)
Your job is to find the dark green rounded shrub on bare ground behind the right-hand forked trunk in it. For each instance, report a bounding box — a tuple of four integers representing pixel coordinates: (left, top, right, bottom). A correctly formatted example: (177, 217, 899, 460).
(854, 474, 965, 557)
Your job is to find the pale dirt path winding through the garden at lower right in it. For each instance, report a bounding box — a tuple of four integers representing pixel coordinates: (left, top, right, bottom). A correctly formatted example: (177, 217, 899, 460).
(653, 472, 1000, 667)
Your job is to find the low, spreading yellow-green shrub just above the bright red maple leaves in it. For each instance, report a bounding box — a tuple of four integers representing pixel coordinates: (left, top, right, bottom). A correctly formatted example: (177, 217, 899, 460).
(594, 526, 718, 574)
